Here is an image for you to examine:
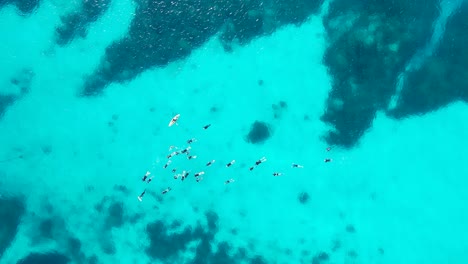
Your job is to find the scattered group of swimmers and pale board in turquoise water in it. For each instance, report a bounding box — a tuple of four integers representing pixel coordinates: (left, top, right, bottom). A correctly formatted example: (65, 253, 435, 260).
(137, 114, 332, 202)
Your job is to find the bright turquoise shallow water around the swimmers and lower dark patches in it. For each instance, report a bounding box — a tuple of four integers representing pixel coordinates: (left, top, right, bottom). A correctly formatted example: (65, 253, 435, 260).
(0, 0, 468, 264)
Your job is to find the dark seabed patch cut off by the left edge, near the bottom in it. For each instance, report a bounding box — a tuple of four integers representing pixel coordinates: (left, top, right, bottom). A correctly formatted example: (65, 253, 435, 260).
(0, 196, 25, 257)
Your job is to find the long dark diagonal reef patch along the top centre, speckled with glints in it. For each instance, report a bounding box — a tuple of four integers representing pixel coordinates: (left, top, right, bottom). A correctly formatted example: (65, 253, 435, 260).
(81, 0, 323, 96)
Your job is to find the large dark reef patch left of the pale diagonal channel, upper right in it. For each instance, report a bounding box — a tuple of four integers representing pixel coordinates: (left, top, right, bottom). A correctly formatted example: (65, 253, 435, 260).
(321, 0, 439, 148)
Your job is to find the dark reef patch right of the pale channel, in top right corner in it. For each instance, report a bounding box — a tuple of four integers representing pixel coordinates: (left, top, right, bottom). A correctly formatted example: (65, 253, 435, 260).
(390, 1, 468, 118)
